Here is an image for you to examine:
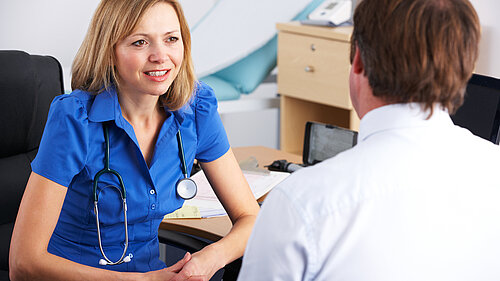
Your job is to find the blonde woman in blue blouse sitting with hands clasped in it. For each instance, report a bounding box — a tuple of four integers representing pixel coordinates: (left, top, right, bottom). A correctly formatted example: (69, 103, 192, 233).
(10, 0, 258, 280)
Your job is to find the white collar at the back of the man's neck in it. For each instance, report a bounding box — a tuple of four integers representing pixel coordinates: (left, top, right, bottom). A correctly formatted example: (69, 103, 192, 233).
(358, 103, 453, 142)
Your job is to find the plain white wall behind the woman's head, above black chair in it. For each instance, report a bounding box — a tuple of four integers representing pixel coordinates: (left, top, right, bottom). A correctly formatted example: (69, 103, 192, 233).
(0, 0, 216, 90)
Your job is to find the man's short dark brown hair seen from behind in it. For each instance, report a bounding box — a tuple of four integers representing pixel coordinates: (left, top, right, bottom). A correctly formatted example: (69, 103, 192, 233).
(351, 0, 480, 114)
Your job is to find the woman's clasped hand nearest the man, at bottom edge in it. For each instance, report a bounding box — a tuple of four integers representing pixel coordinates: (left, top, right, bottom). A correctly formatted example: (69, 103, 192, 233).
(171, 245, 225, 281)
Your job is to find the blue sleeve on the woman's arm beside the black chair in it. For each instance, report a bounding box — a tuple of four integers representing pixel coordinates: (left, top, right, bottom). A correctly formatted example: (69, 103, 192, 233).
(31, 95, 88, 187)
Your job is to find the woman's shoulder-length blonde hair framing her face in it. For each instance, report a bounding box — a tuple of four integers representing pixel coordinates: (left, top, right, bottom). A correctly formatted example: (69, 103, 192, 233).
(71, 0, 196, 110)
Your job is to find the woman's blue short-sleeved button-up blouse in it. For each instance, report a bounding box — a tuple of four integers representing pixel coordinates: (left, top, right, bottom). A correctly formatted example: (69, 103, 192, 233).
(31, 83, 229, 272)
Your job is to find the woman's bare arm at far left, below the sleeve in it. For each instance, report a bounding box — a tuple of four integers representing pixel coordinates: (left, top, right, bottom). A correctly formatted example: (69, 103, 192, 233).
(9, 173, 145, 281)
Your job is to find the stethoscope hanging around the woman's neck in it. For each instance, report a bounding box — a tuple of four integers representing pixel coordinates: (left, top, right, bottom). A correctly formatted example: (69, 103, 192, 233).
(94, 123, 197, 265)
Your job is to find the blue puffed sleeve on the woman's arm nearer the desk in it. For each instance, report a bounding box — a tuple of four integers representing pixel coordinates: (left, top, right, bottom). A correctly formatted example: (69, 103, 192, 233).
(195, 82, 229, 162)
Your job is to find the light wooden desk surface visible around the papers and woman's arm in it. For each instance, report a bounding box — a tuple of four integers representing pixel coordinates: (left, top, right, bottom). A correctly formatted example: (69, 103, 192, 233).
(160, 146, 302, 241)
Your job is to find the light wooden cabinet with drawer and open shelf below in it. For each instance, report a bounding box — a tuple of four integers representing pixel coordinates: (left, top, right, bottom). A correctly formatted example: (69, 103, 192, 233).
(277, 22, 359, 155)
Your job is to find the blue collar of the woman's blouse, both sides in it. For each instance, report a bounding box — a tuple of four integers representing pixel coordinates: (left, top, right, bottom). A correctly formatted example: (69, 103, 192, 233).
(89, 87, 193, 125)
